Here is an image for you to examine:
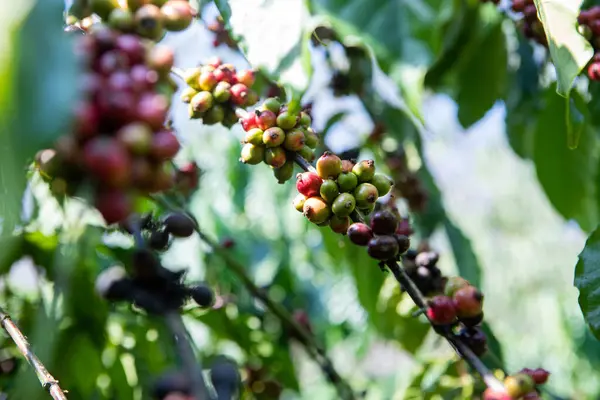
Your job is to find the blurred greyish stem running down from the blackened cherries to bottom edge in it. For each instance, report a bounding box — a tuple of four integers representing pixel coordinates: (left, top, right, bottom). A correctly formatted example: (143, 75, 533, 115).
(164, 312, 213, 400)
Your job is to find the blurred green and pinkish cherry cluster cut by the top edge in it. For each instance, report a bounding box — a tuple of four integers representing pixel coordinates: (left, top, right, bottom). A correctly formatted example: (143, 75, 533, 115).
(69, 0, 197, 41)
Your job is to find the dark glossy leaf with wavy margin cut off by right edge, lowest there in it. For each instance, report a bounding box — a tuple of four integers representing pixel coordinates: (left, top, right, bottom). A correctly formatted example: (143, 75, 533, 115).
(574, 227, 600, 339)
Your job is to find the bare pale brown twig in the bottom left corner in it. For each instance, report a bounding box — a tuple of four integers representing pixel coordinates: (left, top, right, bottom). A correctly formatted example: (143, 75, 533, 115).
(0, 307, 67, 400)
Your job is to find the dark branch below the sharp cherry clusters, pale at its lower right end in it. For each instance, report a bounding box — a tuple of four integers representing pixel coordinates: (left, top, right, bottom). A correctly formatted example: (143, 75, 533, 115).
(386, 261, 505, 391)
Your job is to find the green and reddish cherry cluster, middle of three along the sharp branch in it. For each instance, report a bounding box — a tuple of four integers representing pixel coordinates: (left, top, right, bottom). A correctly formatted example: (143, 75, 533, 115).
(240, 97, 322, 182)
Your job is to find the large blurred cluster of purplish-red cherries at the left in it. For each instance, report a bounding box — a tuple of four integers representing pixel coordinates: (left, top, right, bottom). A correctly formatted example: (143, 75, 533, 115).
(36, 27, 180, 224)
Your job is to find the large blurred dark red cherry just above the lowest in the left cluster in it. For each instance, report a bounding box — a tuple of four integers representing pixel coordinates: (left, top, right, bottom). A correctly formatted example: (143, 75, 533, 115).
(83, 137, 130, 186)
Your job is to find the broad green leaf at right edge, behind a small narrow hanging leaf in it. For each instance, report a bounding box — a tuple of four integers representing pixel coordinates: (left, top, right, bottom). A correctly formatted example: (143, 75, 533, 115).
(533, 87, 598, 231)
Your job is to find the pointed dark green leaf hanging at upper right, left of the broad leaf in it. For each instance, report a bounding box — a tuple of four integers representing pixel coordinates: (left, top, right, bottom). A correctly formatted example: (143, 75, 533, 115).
(456, 23, 508, 128)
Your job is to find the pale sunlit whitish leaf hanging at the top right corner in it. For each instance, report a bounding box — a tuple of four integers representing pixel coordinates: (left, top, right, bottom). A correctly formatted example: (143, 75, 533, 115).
(534, 0, 594, 97)
